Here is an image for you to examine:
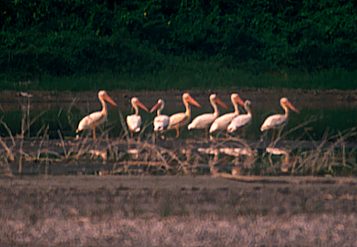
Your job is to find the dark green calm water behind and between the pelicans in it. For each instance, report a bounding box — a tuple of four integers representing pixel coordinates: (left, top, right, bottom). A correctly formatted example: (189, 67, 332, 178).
(0, 99, 357, 140)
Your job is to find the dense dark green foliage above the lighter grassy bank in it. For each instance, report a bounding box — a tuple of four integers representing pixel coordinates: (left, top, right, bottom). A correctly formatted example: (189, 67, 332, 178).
(0, 0, 357, 86)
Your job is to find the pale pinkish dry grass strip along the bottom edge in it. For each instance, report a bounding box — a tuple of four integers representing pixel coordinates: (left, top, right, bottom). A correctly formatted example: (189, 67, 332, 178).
(0, 215, 357, 246)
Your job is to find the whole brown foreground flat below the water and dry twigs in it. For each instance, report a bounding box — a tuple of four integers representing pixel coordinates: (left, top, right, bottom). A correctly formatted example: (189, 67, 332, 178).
(0, 176, 357, 246)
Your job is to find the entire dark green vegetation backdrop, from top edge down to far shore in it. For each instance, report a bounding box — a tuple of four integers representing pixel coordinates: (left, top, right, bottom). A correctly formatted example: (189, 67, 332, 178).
(0, 0, 357, 90)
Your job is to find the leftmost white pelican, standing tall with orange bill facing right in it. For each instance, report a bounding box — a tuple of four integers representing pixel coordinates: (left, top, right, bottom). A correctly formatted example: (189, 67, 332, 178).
(76, 90, 117, 140)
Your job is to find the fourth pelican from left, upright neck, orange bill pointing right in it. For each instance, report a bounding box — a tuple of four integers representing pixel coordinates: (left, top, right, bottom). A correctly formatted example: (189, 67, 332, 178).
(167, 93, 201, 138)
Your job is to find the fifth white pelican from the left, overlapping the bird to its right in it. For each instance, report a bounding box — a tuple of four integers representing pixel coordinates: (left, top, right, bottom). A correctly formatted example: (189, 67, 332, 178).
(187, 94, 228, 130)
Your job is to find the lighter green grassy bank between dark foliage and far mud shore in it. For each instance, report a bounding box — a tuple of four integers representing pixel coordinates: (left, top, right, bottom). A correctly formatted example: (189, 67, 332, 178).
(0, 57, 357, 91)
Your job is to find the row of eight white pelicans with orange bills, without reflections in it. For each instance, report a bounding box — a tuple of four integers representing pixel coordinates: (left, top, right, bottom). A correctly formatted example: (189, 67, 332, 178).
(76, 90, 299, 143)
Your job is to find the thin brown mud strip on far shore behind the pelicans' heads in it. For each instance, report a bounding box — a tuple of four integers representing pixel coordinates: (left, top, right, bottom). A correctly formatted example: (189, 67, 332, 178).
(0, 88, 357, 111)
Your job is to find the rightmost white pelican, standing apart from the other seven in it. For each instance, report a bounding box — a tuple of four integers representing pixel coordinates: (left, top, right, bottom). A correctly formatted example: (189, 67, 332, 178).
(260, 97, 299, 132)
